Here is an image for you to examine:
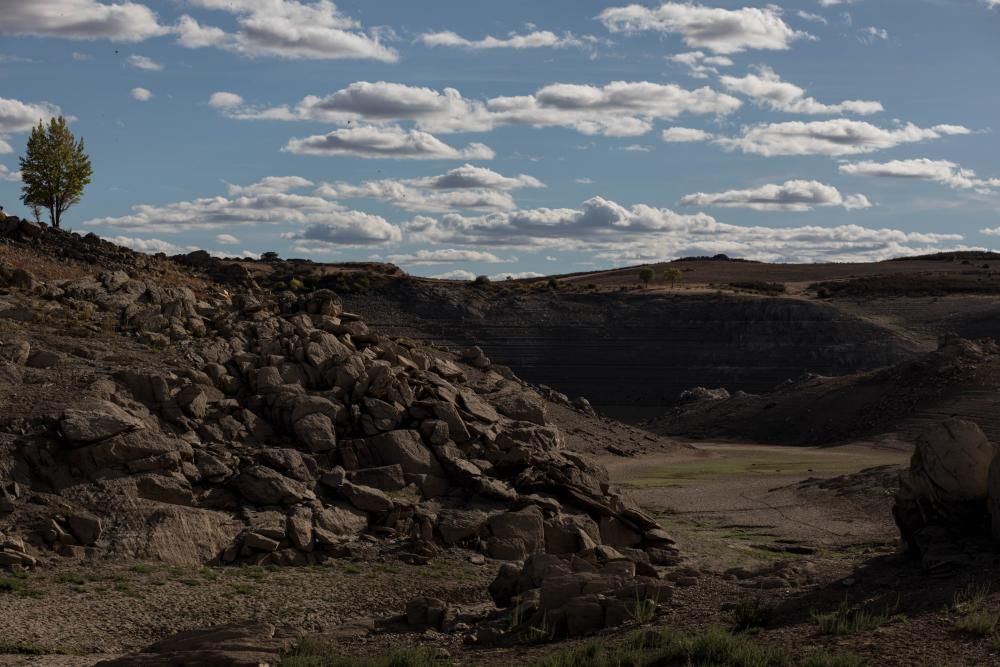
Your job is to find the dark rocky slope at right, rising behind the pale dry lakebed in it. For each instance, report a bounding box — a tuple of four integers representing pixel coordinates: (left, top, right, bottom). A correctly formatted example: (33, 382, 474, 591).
(651, 337, 1000, 444)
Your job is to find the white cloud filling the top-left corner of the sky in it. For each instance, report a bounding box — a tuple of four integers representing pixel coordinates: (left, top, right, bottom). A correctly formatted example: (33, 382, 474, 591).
(0, 0, 167, 42)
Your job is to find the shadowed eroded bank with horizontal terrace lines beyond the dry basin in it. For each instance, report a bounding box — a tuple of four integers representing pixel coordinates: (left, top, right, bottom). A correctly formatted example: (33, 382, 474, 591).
(346, 284, 916, 419)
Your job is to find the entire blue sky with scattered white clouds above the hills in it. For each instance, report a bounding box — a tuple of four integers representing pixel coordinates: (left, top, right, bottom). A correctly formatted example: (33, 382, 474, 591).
(0, 0, 1000, 279)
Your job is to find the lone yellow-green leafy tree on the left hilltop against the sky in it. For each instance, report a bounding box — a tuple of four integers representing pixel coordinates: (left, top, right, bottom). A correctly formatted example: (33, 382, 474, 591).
(21, 116, 93, 229)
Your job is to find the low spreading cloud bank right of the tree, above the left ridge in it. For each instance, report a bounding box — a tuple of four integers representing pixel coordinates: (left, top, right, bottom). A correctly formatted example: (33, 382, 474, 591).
(84, 177, 400, 245)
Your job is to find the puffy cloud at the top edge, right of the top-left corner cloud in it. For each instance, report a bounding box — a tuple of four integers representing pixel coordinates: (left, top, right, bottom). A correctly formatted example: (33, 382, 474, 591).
(174, 0, 399, 63)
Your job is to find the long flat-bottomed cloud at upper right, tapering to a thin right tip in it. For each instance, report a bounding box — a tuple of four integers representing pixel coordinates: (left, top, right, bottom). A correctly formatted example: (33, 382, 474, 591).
(715, 118, 971, 157)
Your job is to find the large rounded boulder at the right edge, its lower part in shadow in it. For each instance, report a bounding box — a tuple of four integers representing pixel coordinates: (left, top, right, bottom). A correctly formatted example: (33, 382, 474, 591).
(892, 418, 1000, 575)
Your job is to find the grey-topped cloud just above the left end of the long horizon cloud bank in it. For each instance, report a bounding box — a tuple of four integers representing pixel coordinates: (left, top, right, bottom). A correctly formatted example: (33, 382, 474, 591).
(317, 164, 545, 213)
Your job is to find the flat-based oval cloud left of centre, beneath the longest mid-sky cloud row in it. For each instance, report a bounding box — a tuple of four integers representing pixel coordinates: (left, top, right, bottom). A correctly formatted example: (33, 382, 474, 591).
(282, 125, 496, 160)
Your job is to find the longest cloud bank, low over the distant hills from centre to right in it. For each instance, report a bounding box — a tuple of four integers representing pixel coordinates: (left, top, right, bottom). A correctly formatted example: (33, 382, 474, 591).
(405, 197, 962, 261)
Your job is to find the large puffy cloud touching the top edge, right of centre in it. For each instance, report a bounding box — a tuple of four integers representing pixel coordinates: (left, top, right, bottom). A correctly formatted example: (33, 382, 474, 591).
(598, 2, 809, 54)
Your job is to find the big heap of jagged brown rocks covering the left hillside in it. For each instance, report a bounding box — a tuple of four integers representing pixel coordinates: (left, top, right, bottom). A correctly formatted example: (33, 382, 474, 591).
(0, 231, 677, 634)
